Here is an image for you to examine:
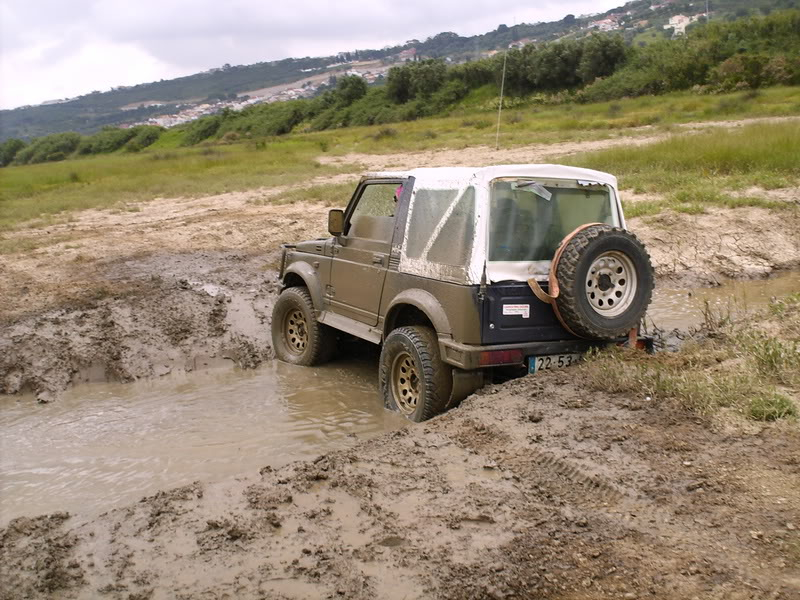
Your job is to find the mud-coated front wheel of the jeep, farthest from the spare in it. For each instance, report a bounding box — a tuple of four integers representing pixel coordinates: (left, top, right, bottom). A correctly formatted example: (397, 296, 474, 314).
(272, 287, 336, 367)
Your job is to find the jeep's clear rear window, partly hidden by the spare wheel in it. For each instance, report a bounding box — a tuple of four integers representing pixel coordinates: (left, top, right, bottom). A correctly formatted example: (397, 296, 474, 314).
(489, 178, 619, 262)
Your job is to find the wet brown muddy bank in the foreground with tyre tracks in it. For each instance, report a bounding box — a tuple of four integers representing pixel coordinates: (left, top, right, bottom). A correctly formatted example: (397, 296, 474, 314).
(0, 369, 800, 600)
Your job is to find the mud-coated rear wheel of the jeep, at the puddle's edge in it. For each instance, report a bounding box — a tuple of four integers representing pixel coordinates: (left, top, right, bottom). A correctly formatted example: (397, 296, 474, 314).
(378, 326, 453, 423)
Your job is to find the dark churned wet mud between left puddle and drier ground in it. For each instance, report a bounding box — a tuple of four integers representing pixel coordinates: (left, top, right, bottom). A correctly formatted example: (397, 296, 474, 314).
(0, 252, 277, 401)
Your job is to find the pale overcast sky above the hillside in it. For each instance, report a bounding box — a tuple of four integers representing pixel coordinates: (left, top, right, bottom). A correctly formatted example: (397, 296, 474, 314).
(0, 0, 625, 108)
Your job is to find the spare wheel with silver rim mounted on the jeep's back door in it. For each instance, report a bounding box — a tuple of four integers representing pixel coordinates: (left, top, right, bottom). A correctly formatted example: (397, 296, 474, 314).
(556, 225, 654, 340)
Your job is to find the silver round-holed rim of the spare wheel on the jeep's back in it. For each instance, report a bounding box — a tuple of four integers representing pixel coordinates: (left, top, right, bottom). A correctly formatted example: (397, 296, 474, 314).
(586, 250, 637, 318)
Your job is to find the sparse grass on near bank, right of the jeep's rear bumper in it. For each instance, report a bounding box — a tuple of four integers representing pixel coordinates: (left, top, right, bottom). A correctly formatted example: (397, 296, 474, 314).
(584, 294, 800, 421)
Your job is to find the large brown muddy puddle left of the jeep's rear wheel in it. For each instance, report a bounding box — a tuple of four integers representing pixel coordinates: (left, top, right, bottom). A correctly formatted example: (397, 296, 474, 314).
(0, 355, 407, 524)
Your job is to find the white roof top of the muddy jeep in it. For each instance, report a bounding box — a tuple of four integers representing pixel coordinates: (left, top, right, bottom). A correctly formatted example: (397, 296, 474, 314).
(365, 165, 617, 187)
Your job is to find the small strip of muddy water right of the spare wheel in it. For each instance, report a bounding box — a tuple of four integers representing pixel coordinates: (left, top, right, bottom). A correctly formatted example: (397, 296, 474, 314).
(647, 271, 800, 331)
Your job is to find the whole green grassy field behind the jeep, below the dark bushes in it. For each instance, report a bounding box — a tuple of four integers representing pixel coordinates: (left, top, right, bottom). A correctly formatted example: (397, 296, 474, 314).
(0, 87, 800, 230)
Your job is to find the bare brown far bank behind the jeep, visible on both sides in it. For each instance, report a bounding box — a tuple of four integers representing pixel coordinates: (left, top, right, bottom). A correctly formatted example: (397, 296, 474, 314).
(6, 197, 800, 401)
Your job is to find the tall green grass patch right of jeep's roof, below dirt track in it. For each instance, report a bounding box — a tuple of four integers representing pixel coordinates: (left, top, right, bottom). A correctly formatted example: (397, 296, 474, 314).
(566, 118, 800, 217)
